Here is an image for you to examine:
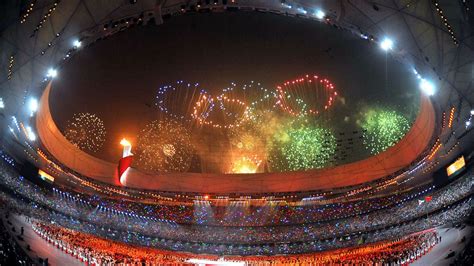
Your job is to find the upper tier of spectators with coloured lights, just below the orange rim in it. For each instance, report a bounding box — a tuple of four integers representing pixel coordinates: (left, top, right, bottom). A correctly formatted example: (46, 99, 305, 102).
(0, 157, 440, 226)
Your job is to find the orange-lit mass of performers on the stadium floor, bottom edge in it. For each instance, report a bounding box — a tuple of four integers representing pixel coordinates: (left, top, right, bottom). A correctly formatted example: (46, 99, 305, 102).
(33, 223, 439, 265)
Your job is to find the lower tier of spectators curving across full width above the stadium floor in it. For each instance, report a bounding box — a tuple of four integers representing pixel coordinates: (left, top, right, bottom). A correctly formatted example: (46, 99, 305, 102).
(0, 161, 474, 240)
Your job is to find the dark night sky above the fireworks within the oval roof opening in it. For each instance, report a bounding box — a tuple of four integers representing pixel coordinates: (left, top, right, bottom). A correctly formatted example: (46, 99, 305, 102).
(51, 13, 417, 170)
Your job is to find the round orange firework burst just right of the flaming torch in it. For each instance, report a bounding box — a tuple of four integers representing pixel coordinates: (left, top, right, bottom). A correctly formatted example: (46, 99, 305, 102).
(136, 118, 194, 172)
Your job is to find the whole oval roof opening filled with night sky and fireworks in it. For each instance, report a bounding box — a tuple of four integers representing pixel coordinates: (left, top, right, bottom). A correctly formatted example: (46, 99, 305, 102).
(51, 13, 419, 173)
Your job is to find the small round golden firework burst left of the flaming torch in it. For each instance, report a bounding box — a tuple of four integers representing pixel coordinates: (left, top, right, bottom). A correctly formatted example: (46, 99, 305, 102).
(64, 113, 107, 152)
